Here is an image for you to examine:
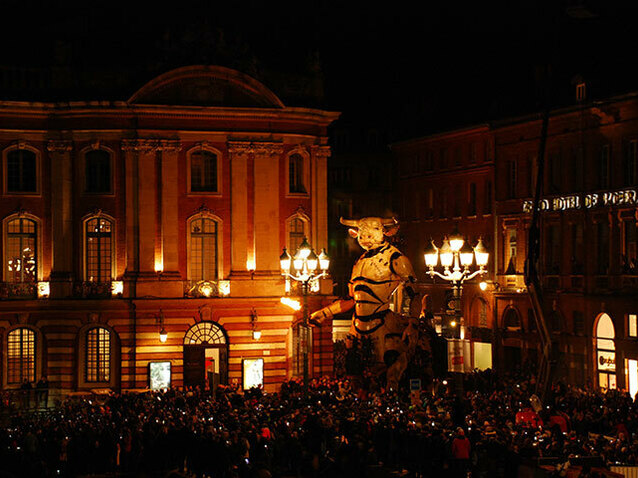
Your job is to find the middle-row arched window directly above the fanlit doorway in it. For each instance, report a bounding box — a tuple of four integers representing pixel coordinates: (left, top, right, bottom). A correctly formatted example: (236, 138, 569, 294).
(189, 217, 218, 282)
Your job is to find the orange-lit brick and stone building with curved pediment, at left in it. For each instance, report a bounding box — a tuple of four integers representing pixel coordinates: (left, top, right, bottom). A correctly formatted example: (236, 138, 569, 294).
(0, 66, 338, 393)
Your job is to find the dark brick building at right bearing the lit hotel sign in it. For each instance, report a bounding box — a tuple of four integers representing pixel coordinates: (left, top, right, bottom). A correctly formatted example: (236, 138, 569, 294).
(393, 91, 638, 393)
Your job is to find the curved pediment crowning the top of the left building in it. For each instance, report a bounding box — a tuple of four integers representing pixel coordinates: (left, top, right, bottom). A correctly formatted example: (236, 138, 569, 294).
(128, 65, 284, 108)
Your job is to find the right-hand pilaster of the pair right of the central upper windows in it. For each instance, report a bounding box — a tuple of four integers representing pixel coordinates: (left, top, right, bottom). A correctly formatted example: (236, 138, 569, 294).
(254, 143, 283, 275)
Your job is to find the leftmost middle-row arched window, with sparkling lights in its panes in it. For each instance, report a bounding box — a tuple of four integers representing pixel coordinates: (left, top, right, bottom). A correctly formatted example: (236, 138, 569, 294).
(5, 218, 38, 282)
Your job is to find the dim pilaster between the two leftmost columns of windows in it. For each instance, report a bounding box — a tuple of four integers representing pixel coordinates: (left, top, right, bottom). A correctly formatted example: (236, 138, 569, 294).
(47, 140, 73, 298)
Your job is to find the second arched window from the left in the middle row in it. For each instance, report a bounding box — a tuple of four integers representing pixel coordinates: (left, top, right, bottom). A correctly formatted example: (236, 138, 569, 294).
(84, 217, 113, 282)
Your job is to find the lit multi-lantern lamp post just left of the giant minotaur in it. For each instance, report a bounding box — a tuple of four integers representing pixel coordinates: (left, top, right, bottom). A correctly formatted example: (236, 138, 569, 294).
(279, 237, 330, 388)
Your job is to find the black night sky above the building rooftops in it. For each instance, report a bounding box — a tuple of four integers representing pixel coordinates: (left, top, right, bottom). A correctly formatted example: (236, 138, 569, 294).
(0, 0, 638, 135)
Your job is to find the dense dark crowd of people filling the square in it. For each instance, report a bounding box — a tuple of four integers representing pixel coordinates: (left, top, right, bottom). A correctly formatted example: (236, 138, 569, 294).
(0, 371, 638, 477)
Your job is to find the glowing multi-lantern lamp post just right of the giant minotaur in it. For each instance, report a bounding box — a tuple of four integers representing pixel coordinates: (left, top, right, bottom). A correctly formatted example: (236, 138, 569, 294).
(423, 228, 489, 336)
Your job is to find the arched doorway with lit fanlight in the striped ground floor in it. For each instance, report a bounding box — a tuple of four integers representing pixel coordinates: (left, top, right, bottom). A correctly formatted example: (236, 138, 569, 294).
(184, 322, 228, 390)
